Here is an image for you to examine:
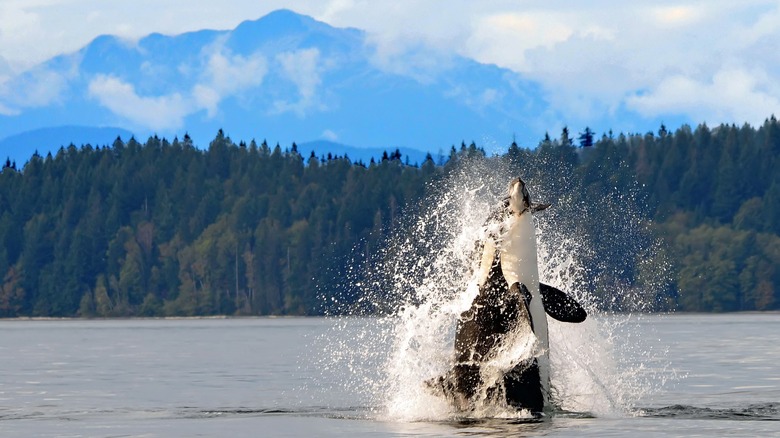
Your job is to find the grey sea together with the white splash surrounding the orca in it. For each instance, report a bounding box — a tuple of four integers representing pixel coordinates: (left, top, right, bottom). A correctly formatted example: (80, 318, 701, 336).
(0, 166, 780, 438)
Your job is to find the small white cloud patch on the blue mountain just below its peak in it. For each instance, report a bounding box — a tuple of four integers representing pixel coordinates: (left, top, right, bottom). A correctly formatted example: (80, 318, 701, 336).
(274, 48, 322, 116)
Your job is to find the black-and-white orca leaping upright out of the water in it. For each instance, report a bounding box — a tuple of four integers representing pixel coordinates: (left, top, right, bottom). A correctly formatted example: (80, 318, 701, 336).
(428, 178, 587, 416)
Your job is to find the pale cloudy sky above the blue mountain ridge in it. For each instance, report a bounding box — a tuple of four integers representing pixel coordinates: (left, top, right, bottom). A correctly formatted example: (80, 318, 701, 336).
(0, 0, 780, 132)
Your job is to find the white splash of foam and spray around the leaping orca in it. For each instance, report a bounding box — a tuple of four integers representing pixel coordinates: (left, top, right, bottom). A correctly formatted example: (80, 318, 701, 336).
(316, 159, 663, 421)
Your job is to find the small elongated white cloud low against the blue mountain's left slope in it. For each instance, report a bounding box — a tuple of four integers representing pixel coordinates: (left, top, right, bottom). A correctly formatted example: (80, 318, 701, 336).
(89, 75, 193, 131)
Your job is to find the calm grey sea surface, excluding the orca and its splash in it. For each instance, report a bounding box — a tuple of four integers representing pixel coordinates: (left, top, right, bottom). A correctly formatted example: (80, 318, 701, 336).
(0, 313, 780, 437)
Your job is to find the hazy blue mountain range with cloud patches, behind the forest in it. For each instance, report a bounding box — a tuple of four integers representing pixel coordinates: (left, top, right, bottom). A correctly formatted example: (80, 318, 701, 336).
(0, 10, 676, 166)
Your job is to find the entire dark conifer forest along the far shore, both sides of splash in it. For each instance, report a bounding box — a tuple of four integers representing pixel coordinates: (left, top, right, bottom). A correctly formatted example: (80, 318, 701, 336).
(0, 117, 780, 317)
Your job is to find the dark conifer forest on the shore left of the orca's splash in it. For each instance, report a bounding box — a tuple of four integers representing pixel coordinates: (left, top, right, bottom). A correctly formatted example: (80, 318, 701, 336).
(0, 132, 434, 316)
